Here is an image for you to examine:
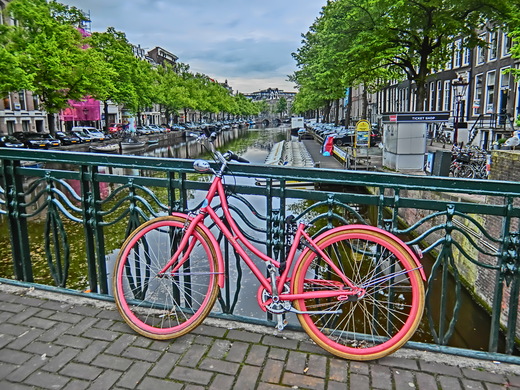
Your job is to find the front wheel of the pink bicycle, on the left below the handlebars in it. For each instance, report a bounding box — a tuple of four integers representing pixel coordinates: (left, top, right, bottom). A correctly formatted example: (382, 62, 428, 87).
(112, 216, 220, 340)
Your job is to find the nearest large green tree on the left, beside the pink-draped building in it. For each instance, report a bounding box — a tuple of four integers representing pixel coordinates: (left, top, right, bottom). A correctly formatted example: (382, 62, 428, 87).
(2, 0, 109, 133)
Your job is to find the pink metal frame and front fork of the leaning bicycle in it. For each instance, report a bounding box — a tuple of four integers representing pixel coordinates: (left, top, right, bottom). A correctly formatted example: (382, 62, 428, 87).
(160, 174, 362, 301)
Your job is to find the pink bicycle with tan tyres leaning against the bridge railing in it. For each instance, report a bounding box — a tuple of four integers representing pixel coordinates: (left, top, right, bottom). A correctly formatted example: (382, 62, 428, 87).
(113, 136, 425, 360)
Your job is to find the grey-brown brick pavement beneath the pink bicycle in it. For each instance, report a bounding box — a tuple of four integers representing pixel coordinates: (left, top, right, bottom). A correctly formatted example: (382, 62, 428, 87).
(0, 284, 520, 390)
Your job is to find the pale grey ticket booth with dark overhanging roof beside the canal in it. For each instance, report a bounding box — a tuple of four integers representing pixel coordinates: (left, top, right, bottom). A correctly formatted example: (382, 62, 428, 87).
(383, 112, 450, 171)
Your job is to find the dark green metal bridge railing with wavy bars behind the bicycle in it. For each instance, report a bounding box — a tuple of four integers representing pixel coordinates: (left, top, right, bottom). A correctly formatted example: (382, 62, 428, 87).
(0, 148, 520, 362)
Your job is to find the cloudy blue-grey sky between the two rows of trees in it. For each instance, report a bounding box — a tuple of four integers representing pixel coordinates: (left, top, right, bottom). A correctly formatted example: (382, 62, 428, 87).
(59, 0, 327, 93)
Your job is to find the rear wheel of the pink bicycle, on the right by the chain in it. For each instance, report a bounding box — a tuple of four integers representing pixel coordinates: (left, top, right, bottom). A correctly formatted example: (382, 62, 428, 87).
(292, 225, 424, 360)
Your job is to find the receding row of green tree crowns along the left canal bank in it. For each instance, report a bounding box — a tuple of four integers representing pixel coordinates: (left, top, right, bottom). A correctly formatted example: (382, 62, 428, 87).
(0, 0, 258, 132)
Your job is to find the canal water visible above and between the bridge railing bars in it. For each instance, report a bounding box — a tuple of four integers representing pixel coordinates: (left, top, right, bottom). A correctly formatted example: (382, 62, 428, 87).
(0, 128, 512, 350)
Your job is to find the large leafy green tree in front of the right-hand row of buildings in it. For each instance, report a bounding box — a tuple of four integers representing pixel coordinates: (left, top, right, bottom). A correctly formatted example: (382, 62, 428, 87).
(296, 0, 514, 110)
